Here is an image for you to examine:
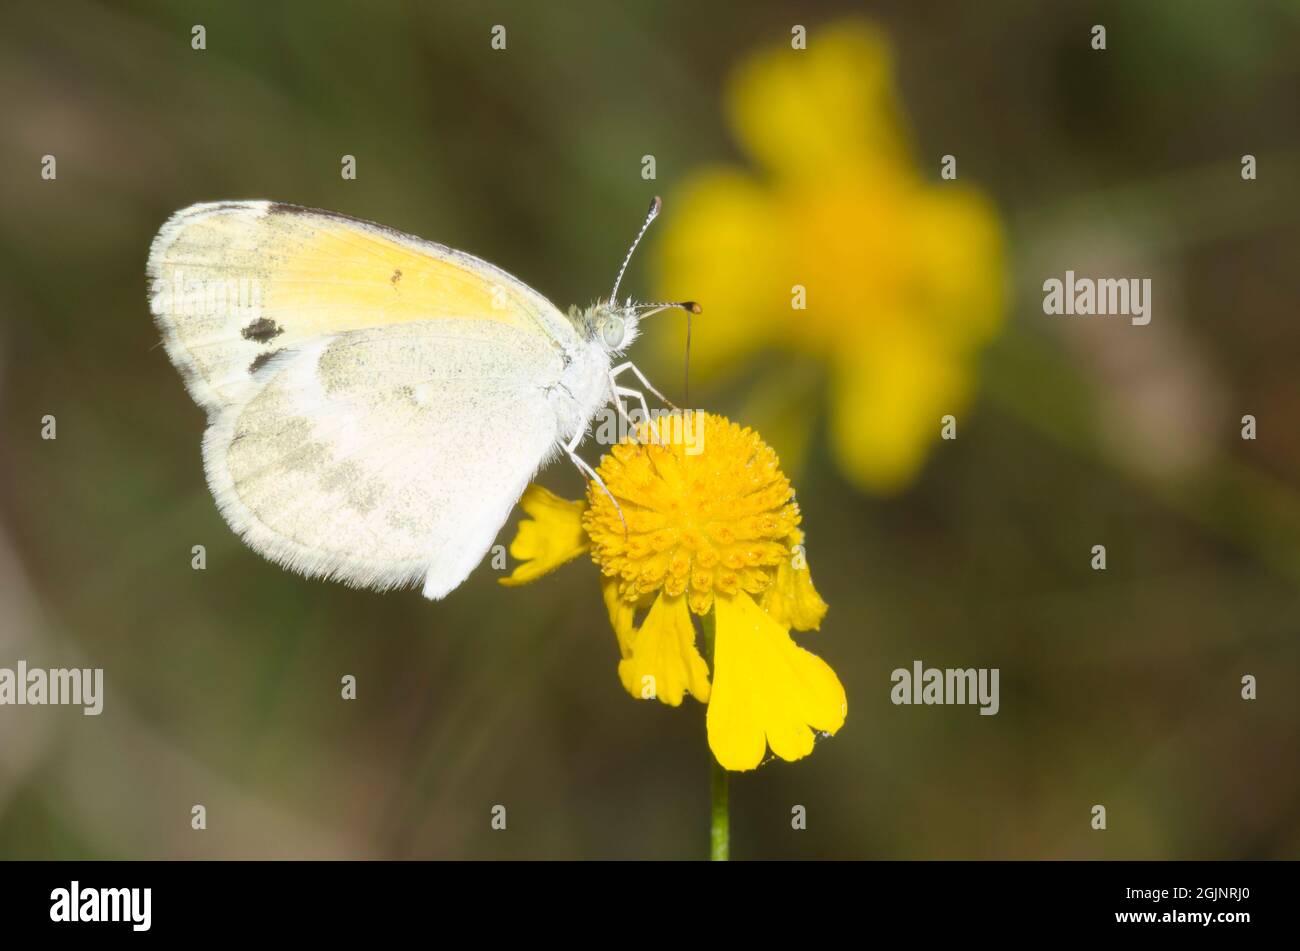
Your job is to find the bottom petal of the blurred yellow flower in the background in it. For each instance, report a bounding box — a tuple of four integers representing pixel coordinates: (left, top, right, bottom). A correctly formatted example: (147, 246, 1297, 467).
(831, 321, 972, 494)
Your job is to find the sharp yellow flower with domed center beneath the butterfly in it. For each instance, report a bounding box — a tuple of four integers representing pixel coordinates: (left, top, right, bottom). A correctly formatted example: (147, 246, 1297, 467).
(503, 413, 846, 770)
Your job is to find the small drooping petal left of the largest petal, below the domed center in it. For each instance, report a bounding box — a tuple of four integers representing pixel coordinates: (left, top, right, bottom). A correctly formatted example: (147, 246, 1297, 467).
(619, 595, 709, 707)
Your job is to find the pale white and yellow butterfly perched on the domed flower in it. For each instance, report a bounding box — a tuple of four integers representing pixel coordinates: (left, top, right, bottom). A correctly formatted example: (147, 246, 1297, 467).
(148, 199, 699, 599)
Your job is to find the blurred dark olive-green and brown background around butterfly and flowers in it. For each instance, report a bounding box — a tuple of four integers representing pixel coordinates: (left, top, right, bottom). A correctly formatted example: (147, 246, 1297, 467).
(0, 0, 1300, 859)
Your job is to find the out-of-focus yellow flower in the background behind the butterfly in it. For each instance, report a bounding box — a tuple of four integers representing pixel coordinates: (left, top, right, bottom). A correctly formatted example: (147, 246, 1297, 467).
(658, 21, 1005, 492)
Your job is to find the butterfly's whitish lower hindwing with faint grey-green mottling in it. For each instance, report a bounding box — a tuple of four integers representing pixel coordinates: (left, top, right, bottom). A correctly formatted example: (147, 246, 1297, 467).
(204, 318, 563, 598)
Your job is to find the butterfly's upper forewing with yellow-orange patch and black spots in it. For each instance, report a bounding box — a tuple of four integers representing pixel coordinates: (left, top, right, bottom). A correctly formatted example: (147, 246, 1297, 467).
(148, 201, 577, 409)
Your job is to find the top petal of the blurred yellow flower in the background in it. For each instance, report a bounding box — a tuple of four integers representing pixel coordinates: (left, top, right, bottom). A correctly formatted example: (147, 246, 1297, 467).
(728, 22, 907, 181)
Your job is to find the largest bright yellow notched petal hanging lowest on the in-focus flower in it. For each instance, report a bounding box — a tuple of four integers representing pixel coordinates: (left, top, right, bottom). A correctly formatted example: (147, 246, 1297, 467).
(707, 592, 848, 770)
